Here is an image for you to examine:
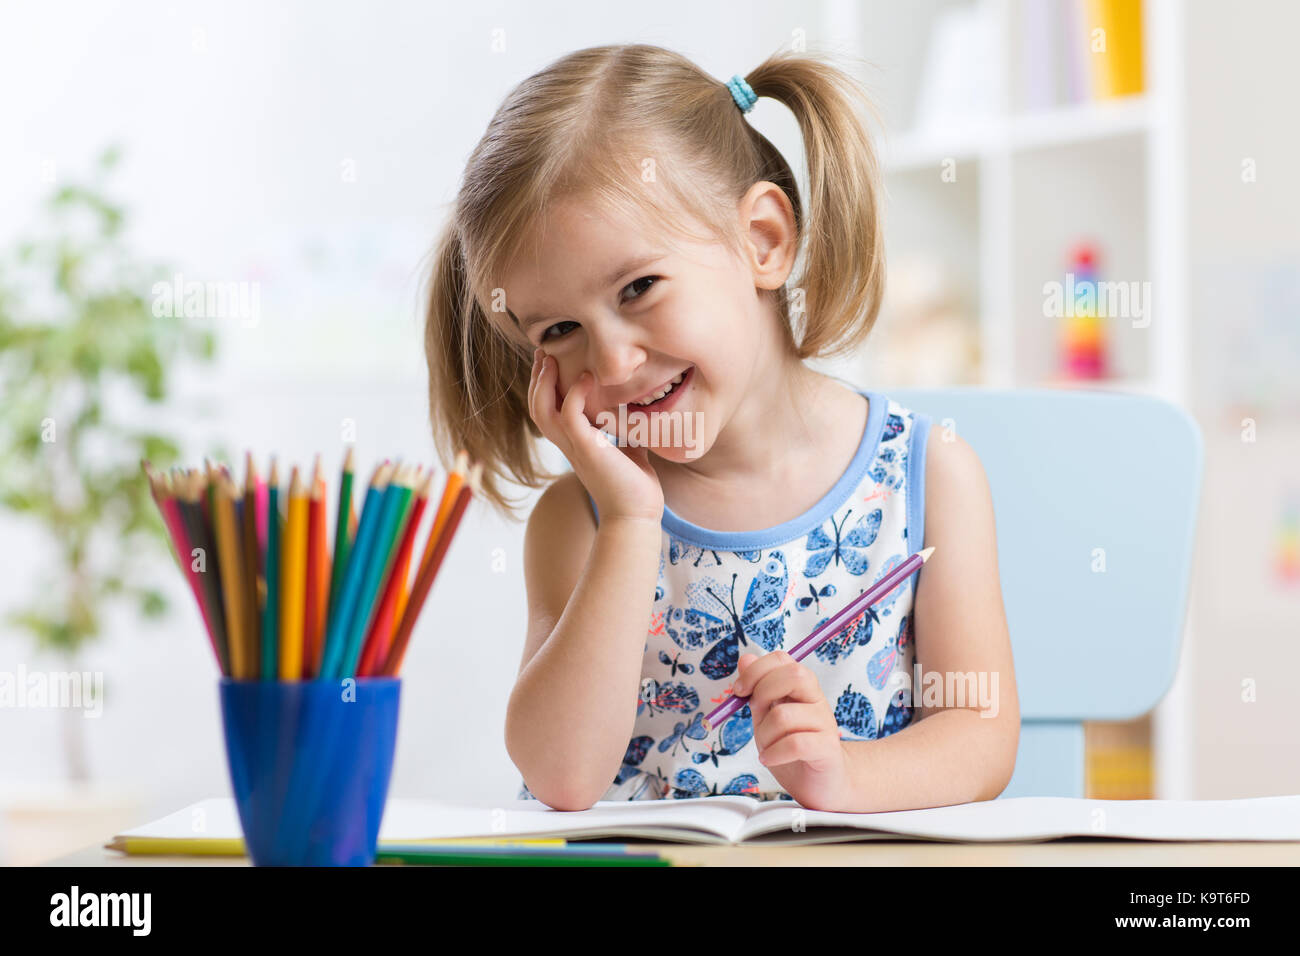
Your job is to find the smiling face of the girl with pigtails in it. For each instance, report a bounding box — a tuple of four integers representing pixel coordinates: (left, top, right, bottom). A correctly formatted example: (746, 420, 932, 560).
(504, 187, 788, 462)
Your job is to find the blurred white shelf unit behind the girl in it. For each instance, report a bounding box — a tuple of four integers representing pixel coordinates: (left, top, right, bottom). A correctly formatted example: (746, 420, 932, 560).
(826, 0, 1193, 799)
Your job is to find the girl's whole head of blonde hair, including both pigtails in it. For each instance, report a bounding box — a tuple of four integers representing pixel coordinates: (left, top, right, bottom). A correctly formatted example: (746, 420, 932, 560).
(425, 44, 884, 522)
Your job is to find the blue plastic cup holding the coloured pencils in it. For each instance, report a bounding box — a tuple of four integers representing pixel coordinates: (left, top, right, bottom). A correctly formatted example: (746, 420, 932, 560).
(221, 678, 402, 866)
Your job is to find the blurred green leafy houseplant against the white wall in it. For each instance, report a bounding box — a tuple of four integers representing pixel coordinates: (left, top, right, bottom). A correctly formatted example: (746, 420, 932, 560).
(0, 147, 215, 782)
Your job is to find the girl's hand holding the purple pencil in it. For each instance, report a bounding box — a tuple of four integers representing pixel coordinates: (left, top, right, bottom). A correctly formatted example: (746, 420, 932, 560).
(732, 650, 853, 810)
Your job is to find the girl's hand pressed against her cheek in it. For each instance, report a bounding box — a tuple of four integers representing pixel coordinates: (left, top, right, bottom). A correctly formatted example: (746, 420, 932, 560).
(528, 349, 663, 524)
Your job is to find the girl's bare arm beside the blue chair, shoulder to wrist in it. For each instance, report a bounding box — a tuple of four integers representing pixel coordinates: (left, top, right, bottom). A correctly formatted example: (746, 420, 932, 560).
(842, 428, 1021, 813)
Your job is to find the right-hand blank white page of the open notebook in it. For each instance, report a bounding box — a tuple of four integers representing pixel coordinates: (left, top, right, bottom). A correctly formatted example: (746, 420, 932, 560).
(742, 795, 1300, 843)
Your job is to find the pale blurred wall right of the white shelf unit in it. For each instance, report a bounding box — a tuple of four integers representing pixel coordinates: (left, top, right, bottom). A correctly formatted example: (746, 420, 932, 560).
(1187, 0, 1300, 799)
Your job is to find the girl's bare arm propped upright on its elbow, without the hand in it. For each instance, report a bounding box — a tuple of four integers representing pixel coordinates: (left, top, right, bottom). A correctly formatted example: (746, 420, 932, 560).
(506, 473, 662, 810)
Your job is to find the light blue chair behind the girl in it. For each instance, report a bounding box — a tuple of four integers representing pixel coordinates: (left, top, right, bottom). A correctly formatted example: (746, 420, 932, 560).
(885, 388, 1204, 797)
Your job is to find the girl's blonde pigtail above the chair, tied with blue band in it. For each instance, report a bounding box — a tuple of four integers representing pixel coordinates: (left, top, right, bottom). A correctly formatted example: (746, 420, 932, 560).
(745, 52, 885, 358)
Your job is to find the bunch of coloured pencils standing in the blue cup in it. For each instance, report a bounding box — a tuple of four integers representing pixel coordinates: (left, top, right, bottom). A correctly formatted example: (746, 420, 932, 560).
(140, 449, 482, 680)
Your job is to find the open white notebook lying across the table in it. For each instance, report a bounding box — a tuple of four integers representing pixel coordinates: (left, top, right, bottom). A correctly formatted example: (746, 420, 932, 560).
(108, 795, 1300, 853)
